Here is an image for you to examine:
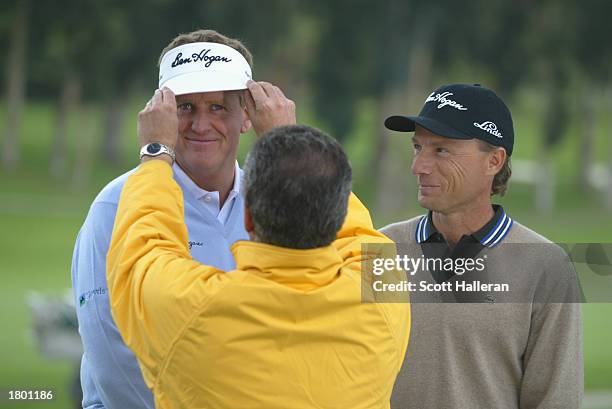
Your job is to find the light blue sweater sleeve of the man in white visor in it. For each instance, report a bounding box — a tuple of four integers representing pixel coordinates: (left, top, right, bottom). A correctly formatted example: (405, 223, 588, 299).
(72, 202, 154, 409)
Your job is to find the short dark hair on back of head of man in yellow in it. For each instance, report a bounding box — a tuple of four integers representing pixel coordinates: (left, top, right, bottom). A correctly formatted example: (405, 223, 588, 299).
(244, 125, 351, 249)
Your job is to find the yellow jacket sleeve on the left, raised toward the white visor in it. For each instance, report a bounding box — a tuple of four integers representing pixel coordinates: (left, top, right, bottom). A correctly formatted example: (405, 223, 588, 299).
(107, 160, 229, 387)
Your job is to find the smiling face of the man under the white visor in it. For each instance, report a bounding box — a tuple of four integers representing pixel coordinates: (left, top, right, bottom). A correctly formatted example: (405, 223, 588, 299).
(175, 91, 250, 184)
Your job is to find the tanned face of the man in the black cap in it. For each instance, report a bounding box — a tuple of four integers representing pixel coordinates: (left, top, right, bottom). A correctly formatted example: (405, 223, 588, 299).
(412, 125, 505, 214)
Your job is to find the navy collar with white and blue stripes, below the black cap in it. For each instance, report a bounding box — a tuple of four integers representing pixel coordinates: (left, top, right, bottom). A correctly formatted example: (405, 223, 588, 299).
(415, 205, 514, 247)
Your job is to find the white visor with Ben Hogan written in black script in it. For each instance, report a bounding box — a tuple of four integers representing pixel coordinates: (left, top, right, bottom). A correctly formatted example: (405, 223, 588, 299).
(159, 43, 252, 95)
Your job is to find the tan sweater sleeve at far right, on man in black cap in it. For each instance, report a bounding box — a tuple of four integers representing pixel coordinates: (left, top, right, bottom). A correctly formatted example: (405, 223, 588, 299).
(520, 250, 584, 409)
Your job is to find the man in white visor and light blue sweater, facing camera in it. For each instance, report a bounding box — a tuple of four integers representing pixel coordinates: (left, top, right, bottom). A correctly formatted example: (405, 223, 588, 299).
(72, 30, 295, 409)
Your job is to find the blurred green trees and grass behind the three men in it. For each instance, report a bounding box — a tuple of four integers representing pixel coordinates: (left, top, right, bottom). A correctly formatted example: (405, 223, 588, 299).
(0, 0, 612, 408)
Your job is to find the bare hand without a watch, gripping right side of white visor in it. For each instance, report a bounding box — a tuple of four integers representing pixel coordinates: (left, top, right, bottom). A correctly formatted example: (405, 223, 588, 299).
(245, 81, 296, 136)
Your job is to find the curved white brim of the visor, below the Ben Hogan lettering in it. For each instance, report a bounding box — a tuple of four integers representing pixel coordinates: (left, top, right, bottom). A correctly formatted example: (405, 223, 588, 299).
(159, 71, 249, 95)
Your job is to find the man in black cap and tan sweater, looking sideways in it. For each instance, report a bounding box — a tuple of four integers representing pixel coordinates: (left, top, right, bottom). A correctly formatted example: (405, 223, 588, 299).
(381, 84, 583, 409)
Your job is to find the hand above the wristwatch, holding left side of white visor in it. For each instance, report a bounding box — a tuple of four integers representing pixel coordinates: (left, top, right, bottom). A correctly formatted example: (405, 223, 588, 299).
(138, 87, 178, 150)
